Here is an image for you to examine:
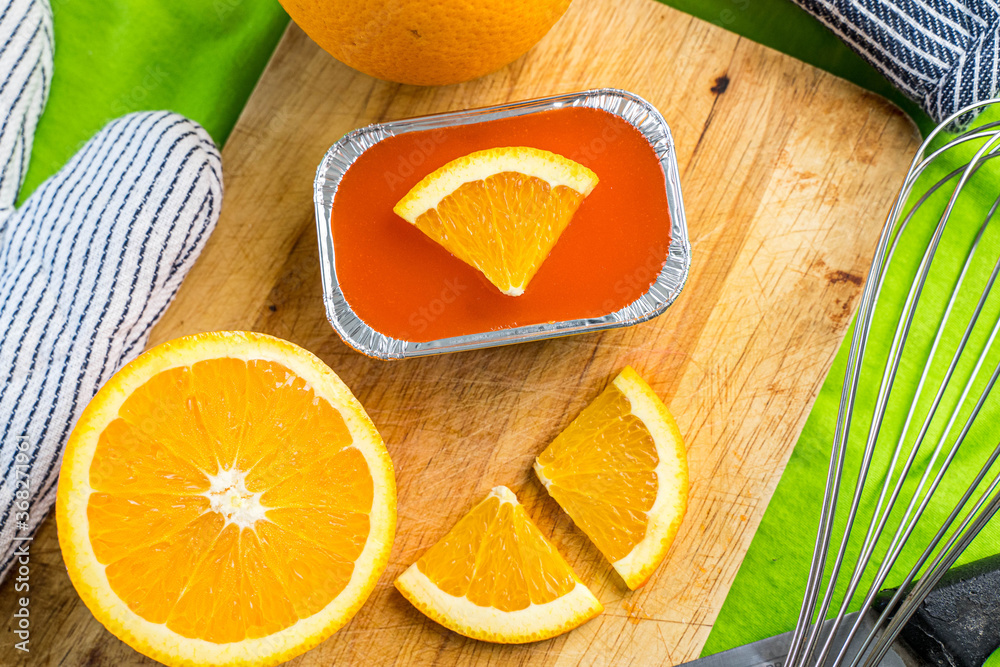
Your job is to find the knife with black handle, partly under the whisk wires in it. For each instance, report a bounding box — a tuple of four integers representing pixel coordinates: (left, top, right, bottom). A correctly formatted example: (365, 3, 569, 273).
(683, 554, 1000, 667)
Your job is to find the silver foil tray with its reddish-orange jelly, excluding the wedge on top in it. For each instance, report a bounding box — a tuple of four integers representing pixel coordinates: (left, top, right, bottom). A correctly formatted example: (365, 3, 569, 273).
(315, 89, 690, 359)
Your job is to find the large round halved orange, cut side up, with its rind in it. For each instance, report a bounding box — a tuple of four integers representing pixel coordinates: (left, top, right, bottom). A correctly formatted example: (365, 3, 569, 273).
(56, 332, 396, 665)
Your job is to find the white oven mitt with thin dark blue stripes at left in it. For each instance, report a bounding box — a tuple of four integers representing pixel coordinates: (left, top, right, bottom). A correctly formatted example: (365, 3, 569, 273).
(0, 0, 222, 578)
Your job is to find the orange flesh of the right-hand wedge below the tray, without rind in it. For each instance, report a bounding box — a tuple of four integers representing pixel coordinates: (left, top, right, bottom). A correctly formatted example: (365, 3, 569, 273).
(538, 385, 660, 563)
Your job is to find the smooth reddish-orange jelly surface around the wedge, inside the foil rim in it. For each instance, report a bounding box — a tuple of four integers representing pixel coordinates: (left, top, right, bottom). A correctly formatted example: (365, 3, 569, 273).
(331, 108, 670, 342)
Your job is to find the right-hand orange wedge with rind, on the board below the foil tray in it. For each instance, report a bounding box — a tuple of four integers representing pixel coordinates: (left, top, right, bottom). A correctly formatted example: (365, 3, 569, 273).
(535, 366, 688, 590)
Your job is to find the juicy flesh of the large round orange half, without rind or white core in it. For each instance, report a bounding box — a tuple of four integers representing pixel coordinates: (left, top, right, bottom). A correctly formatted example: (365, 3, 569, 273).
(87, 359, 374, 643)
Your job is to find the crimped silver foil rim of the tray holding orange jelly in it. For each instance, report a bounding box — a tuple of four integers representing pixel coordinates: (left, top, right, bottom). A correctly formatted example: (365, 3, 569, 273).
(313, 88, 691, 360)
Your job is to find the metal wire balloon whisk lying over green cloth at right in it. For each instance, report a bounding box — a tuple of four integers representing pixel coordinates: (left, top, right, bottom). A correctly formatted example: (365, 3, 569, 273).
(785, 100, 1000, 667)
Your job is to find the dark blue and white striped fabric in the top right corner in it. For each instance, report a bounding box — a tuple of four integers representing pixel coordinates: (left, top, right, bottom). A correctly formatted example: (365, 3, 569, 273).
(794, 0, 1000, 126)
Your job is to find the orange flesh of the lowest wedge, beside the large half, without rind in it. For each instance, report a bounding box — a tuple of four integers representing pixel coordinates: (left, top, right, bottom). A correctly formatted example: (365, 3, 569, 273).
(417, 497, 576, 611)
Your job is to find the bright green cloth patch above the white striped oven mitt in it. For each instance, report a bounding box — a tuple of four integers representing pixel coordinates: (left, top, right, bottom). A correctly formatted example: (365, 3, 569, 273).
(21, 0, 288, 201)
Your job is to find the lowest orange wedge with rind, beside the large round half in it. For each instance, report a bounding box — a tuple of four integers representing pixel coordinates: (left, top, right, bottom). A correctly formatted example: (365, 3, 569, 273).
(396, 486, 604, 644)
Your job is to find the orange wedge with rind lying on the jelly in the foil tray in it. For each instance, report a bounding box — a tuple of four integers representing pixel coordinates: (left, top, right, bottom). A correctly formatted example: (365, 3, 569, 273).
(393, 146, 598, 296)
